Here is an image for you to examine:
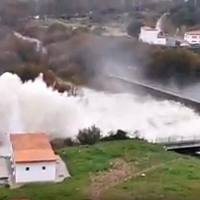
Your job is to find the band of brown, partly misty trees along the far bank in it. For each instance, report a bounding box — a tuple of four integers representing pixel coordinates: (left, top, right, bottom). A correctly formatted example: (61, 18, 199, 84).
(0, 20, 200, 90)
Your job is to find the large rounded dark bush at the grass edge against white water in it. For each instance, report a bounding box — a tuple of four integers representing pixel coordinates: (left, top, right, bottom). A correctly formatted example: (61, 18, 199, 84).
(77, 126, 101, 145)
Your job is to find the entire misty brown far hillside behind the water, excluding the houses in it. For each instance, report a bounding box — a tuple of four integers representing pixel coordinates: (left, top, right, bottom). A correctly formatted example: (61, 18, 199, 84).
(0, 0, 200, 91)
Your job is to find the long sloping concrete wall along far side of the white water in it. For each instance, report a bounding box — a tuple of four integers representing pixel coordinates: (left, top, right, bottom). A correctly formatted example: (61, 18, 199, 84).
(107, 75, 200, 113)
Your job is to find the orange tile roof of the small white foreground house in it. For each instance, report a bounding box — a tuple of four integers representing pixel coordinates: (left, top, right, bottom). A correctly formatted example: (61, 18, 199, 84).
(10, 133, 57, 163)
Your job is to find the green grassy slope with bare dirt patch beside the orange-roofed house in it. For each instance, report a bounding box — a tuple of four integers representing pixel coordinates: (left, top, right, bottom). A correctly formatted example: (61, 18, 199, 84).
(0, 140, 200, 200)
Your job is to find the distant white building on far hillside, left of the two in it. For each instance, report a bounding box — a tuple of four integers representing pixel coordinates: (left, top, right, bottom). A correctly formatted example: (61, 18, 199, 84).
(139, 26, 167, 45)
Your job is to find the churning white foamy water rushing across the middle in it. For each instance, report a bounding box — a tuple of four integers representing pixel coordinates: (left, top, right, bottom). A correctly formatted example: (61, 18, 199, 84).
(0, 73, 200, 150)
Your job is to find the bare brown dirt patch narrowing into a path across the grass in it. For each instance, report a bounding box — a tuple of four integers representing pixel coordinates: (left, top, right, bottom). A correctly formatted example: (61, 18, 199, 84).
(90, 159, 178, 200)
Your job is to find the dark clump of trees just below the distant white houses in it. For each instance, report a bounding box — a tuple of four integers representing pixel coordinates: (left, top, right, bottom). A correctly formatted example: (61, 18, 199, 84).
(145, 48, 200, 86)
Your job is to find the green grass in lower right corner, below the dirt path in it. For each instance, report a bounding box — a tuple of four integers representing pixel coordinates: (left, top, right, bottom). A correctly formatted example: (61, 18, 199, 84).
(102, 158, 200, 200)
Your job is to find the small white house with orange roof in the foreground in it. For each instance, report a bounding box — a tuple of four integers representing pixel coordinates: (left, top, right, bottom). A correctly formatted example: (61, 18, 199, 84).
(10, 133, 57, 183)
